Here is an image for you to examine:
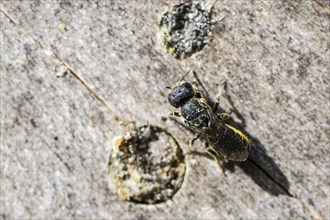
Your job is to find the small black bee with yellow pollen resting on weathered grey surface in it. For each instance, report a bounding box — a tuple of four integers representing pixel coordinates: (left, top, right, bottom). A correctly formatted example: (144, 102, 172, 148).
(167, 72, 251, 165)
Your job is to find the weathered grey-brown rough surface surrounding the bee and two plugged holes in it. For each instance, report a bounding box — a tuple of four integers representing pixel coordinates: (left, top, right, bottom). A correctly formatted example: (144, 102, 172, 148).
(0, 0, 330, 219)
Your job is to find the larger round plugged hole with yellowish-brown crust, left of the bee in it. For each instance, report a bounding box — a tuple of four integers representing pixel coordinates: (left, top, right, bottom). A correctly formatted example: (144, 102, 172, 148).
(108, 125, 186, 204)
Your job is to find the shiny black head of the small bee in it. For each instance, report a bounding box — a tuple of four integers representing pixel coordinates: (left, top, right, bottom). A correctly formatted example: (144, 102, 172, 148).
(168, 83, 195, 108)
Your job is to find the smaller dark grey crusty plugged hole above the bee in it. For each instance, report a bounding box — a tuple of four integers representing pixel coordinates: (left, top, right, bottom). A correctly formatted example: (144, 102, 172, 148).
(160, 1, 213, 59)
